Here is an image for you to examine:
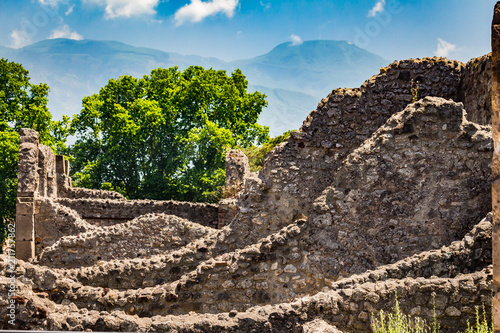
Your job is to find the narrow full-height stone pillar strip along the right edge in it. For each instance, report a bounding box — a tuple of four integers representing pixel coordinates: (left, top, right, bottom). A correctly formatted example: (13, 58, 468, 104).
(491, 1, 500, 332)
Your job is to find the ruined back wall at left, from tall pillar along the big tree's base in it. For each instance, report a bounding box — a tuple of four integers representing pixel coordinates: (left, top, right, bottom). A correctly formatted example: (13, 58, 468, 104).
(16, 129, 218, 262)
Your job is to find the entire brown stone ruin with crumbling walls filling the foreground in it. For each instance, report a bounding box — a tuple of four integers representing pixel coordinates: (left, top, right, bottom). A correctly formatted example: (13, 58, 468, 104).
(0, 26, 495, 332)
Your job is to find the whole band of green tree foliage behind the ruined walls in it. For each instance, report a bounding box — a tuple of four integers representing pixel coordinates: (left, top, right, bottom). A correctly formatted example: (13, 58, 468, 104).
(0, 59, 274, 242)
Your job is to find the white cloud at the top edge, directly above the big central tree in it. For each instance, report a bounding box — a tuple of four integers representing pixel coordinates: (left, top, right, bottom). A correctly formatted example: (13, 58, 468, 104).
(175, 0, 239, 26)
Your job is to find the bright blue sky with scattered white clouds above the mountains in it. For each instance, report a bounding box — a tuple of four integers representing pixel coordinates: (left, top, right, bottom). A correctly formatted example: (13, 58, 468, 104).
(0, 0, 496, 61)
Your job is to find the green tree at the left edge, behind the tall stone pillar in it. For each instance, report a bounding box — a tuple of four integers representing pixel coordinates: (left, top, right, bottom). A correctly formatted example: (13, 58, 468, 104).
(0, 58, 68, 249)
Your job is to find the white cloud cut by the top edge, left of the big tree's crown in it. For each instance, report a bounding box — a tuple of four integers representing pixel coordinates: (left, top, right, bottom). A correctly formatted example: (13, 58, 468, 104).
(84, 0, 160, 19)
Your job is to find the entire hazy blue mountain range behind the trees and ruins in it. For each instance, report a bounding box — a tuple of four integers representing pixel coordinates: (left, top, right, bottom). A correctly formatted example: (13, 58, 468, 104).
(0, 39, 388, 135)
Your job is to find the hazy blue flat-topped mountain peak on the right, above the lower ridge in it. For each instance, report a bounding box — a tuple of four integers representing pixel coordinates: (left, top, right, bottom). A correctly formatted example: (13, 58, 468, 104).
(231, 40, 388, 97)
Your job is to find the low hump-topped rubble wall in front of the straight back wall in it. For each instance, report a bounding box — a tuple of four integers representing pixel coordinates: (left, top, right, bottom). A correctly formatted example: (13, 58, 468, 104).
(39, 214, 215, 268)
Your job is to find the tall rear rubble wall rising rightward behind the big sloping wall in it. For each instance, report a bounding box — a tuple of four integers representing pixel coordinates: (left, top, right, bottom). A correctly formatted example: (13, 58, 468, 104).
(227, 58, 487, 249)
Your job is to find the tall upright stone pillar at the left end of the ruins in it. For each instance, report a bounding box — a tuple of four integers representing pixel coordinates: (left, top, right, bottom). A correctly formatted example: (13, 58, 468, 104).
(16, 128, 39, 260)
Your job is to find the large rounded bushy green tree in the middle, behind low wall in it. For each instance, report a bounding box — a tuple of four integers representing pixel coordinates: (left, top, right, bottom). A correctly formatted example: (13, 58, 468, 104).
(70, 66, 268, 201)
